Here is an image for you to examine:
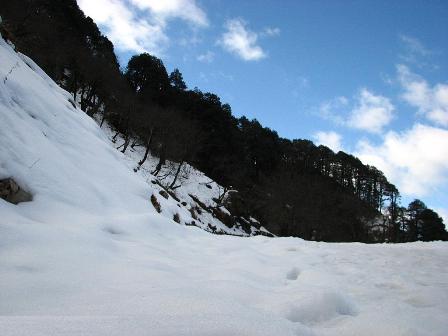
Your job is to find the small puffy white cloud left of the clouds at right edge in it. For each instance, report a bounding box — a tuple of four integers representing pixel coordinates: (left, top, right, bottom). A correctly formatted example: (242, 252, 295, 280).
(347, 89, 395, 133)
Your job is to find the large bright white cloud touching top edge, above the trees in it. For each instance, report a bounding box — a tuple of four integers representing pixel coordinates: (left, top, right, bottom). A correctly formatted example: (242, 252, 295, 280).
(78, 0, 208, 54)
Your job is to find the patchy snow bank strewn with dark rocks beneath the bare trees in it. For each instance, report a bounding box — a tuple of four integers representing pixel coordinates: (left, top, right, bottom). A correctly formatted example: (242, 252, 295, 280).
(99, 125, 273, 237)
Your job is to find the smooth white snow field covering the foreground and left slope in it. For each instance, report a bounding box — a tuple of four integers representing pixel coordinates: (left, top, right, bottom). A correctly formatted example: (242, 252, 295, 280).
(0, 39, 448, 336)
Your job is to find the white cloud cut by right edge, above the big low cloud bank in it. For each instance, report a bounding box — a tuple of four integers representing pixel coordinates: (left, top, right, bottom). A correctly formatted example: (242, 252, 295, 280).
(397, 64, 448, 127)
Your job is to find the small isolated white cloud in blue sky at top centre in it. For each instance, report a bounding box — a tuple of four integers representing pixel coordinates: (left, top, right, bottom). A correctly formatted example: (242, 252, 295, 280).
(218, 19, 266, 61)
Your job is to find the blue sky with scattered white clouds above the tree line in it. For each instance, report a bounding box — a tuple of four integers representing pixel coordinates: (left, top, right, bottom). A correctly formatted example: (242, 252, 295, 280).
(78, 0, 448, 223)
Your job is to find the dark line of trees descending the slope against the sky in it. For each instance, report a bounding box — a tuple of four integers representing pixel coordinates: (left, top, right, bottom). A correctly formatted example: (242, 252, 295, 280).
(0, 0, 447, 242)
